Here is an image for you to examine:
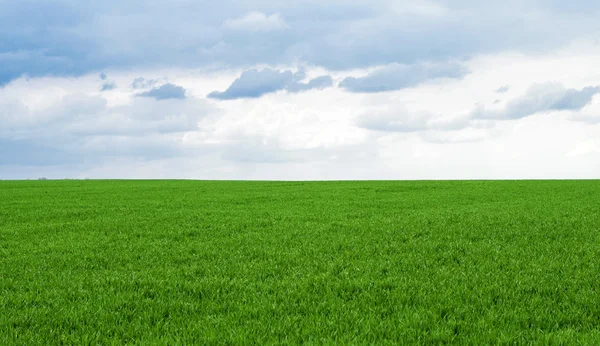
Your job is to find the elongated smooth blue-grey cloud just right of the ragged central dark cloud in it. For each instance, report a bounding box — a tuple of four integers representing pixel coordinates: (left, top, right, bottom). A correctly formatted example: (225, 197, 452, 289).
(340, 63, 468, 93)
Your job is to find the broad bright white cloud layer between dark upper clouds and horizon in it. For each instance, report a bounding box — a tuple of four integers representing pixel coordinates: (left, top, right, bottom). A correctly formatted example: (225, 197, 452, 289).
(0, 41, 600, 179)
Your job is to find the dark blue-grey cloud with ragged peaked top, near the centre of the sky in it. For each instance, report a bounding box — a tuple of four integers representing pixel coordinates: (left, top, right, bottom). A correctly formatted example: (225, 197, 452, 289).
(208, 68, 333, 100)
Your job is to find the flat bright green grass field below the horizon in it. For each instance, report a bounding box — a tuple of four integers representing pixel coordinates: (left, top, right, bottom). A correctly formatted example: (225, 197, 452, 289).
(0, 181, 600, 345)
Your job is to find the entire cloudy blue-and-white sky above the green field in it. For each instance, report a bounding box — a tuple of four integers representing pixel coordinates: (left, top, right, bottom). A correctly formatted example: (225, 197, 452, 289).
(0, 0, 600, 180)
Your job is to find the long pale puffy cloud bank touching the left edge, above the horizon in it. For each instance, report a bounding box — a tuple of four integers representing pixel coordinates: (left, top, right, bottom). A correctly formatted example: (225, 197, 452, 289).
(0, 93, 211, 138)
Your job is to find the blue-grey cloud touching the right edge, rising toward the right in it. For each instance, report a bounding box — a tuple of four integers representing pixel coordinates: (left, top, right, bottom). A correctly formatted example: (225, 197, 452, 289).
(471, 83, 600, 119)
